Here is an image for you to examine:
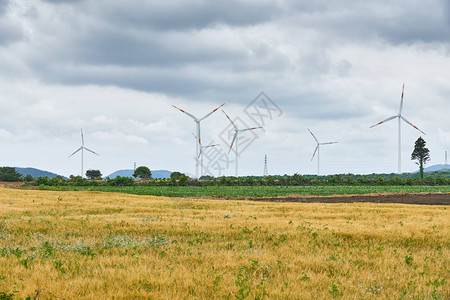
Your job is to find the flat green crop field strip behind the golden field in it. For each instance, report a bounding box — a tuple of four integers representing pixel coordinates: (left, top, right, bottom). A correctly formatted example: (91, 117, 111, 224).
(33, 185, 450, 198)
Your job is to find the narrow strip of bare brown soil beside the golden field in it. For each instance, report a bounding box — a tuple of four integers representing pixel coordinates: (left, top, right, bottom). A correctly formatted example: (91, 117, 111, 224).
(247, 193, 450, 205)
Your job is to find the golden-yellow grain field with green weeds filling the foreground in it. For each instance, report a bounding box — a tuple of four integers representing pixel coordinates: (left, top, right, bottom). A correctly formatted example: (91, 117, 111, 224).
(0, 188, 450, 299)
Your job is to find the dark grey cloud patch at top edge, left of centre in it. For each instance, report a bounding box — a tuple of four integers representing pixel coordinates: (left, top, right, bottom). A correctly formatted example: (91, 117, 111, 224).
(98, 0, 281, 30)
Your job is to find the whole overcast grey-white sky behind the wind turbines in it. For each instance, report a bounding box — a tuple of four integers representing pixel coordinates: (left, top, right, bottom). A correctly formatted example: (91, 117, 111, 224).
(0, 0, 450, 176)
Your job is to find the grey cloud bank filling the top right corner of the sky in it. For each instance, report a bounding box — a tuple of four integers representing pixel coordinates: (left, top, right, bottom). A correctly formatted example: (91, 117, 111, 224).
(292, 0, 450, 44)
